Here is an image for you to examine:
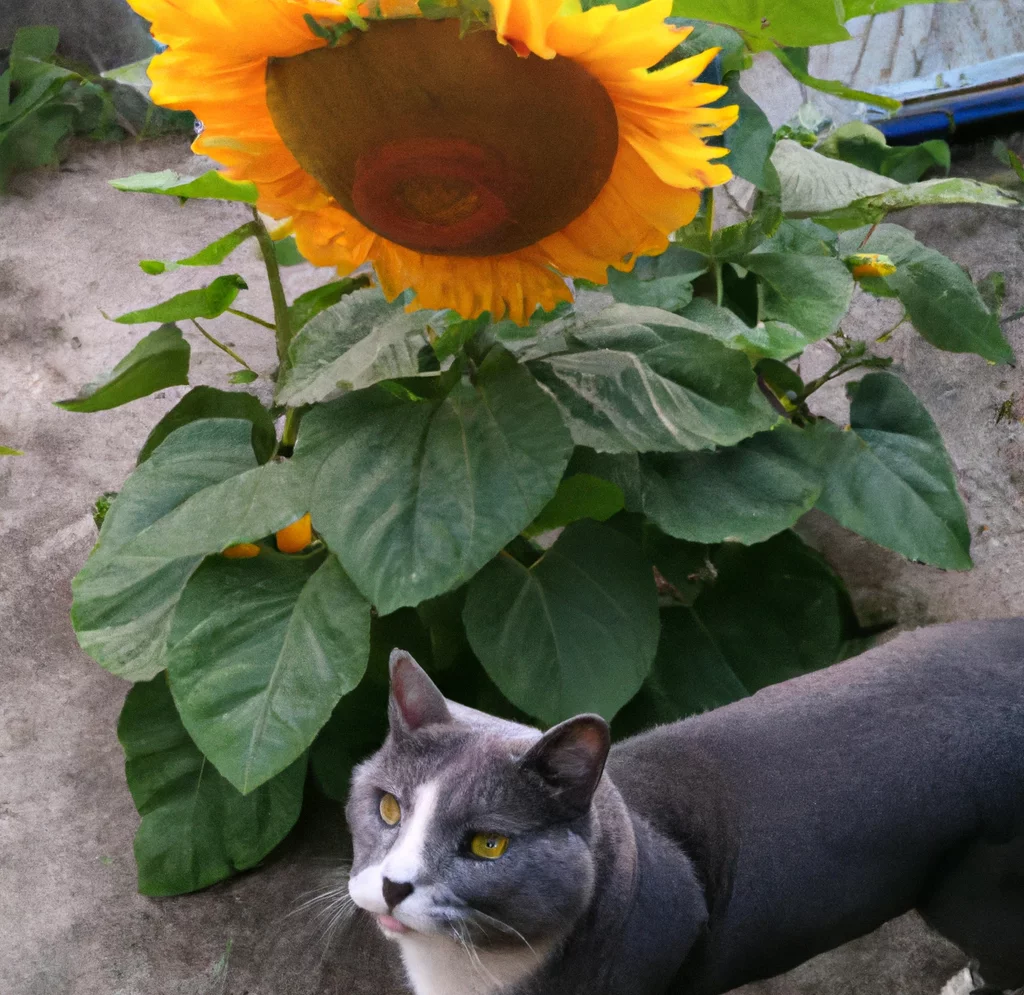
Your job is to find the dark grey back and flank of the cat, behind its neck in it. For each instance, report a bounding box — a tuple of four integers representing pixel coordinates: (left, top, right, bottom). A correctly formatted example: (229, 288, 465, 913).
(608, 619, 1024, 991)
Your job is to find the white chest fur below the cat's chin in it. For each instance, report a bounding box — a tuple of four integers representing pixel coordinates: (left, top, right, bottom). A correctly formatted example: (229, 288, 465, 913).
(398, 936, 546, 995)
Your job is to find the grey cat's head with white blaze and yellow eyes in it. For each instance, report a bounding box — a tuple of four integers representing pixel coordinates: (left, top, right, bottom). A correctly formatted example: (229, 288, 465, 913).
(346, 650, 608, 946)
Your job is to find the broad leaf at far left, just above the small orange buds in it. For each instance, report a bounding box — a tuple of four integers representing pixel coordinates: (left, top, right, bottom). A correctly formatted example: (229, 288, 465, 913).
(72, 419, 292, 681)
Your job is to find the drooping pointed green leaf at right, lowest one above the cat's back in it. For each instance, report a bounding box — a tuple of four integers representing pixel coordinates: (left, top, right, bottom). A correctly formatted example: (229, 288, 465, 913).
(817, 374, 971, 570)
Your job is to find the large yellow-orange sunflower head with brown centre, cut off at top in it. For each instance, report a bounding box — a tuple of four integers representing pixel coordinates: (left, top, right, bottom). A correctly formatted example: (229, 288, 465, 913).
(130, 0, 737, 323)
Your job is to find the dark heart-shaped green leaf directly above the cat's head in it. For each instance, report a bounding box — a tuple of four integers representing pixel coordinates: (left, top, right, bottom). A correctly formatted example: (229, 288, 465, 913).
(463, 521, 658, 724)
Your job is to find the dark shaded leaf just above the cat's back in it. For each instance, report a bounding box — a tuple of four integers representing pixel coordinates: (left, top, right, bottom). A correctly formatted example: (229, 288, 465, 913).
(616, 531, 862, 733)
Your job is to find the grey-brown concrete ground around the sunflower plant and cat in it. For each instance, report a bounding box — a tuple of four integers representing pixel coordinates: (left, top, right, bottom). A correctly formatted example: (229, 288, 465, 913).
(0, 120, 1024, 995)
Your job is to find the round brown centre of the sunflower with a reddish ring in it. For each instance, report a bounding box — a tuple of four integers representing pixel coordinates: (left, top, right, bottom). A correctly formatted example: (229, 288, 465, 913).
(266, 19, 618, 256)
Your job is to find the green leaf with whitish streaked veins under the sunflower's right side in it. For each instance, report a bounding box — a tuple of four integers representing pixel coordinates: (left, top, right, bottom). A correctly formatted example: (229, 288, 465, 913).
(527, 304, 777, 452)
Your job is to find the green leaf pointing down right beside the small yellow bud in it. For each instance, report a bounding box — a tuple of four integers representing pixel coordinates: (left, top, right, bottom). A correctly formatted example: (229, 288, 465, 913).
(840, 224, 1014, 362)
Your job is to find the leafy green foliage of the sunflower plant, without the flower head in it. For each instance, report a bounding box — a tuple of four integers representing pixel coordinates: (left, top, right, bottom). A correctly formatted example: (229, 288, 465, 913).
(60, 0, 1020, 895)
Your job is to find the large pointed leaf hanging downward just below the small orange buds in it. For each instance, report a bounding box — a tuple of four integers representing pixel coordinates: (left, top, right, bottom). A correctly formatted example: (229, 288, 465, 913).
(167, 550, 370, 794)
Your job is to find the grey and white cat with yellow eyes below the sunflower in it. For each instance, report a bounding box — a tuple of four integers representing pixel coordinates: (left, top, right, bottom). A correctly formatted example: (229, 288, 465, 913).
(346, 619, 1024, 995)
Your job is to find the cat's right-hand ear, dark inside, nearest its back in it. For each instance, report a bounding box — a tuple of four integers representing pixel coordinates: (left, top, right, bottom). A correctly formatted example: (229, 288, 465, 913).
(520, 716, 611, 815)
